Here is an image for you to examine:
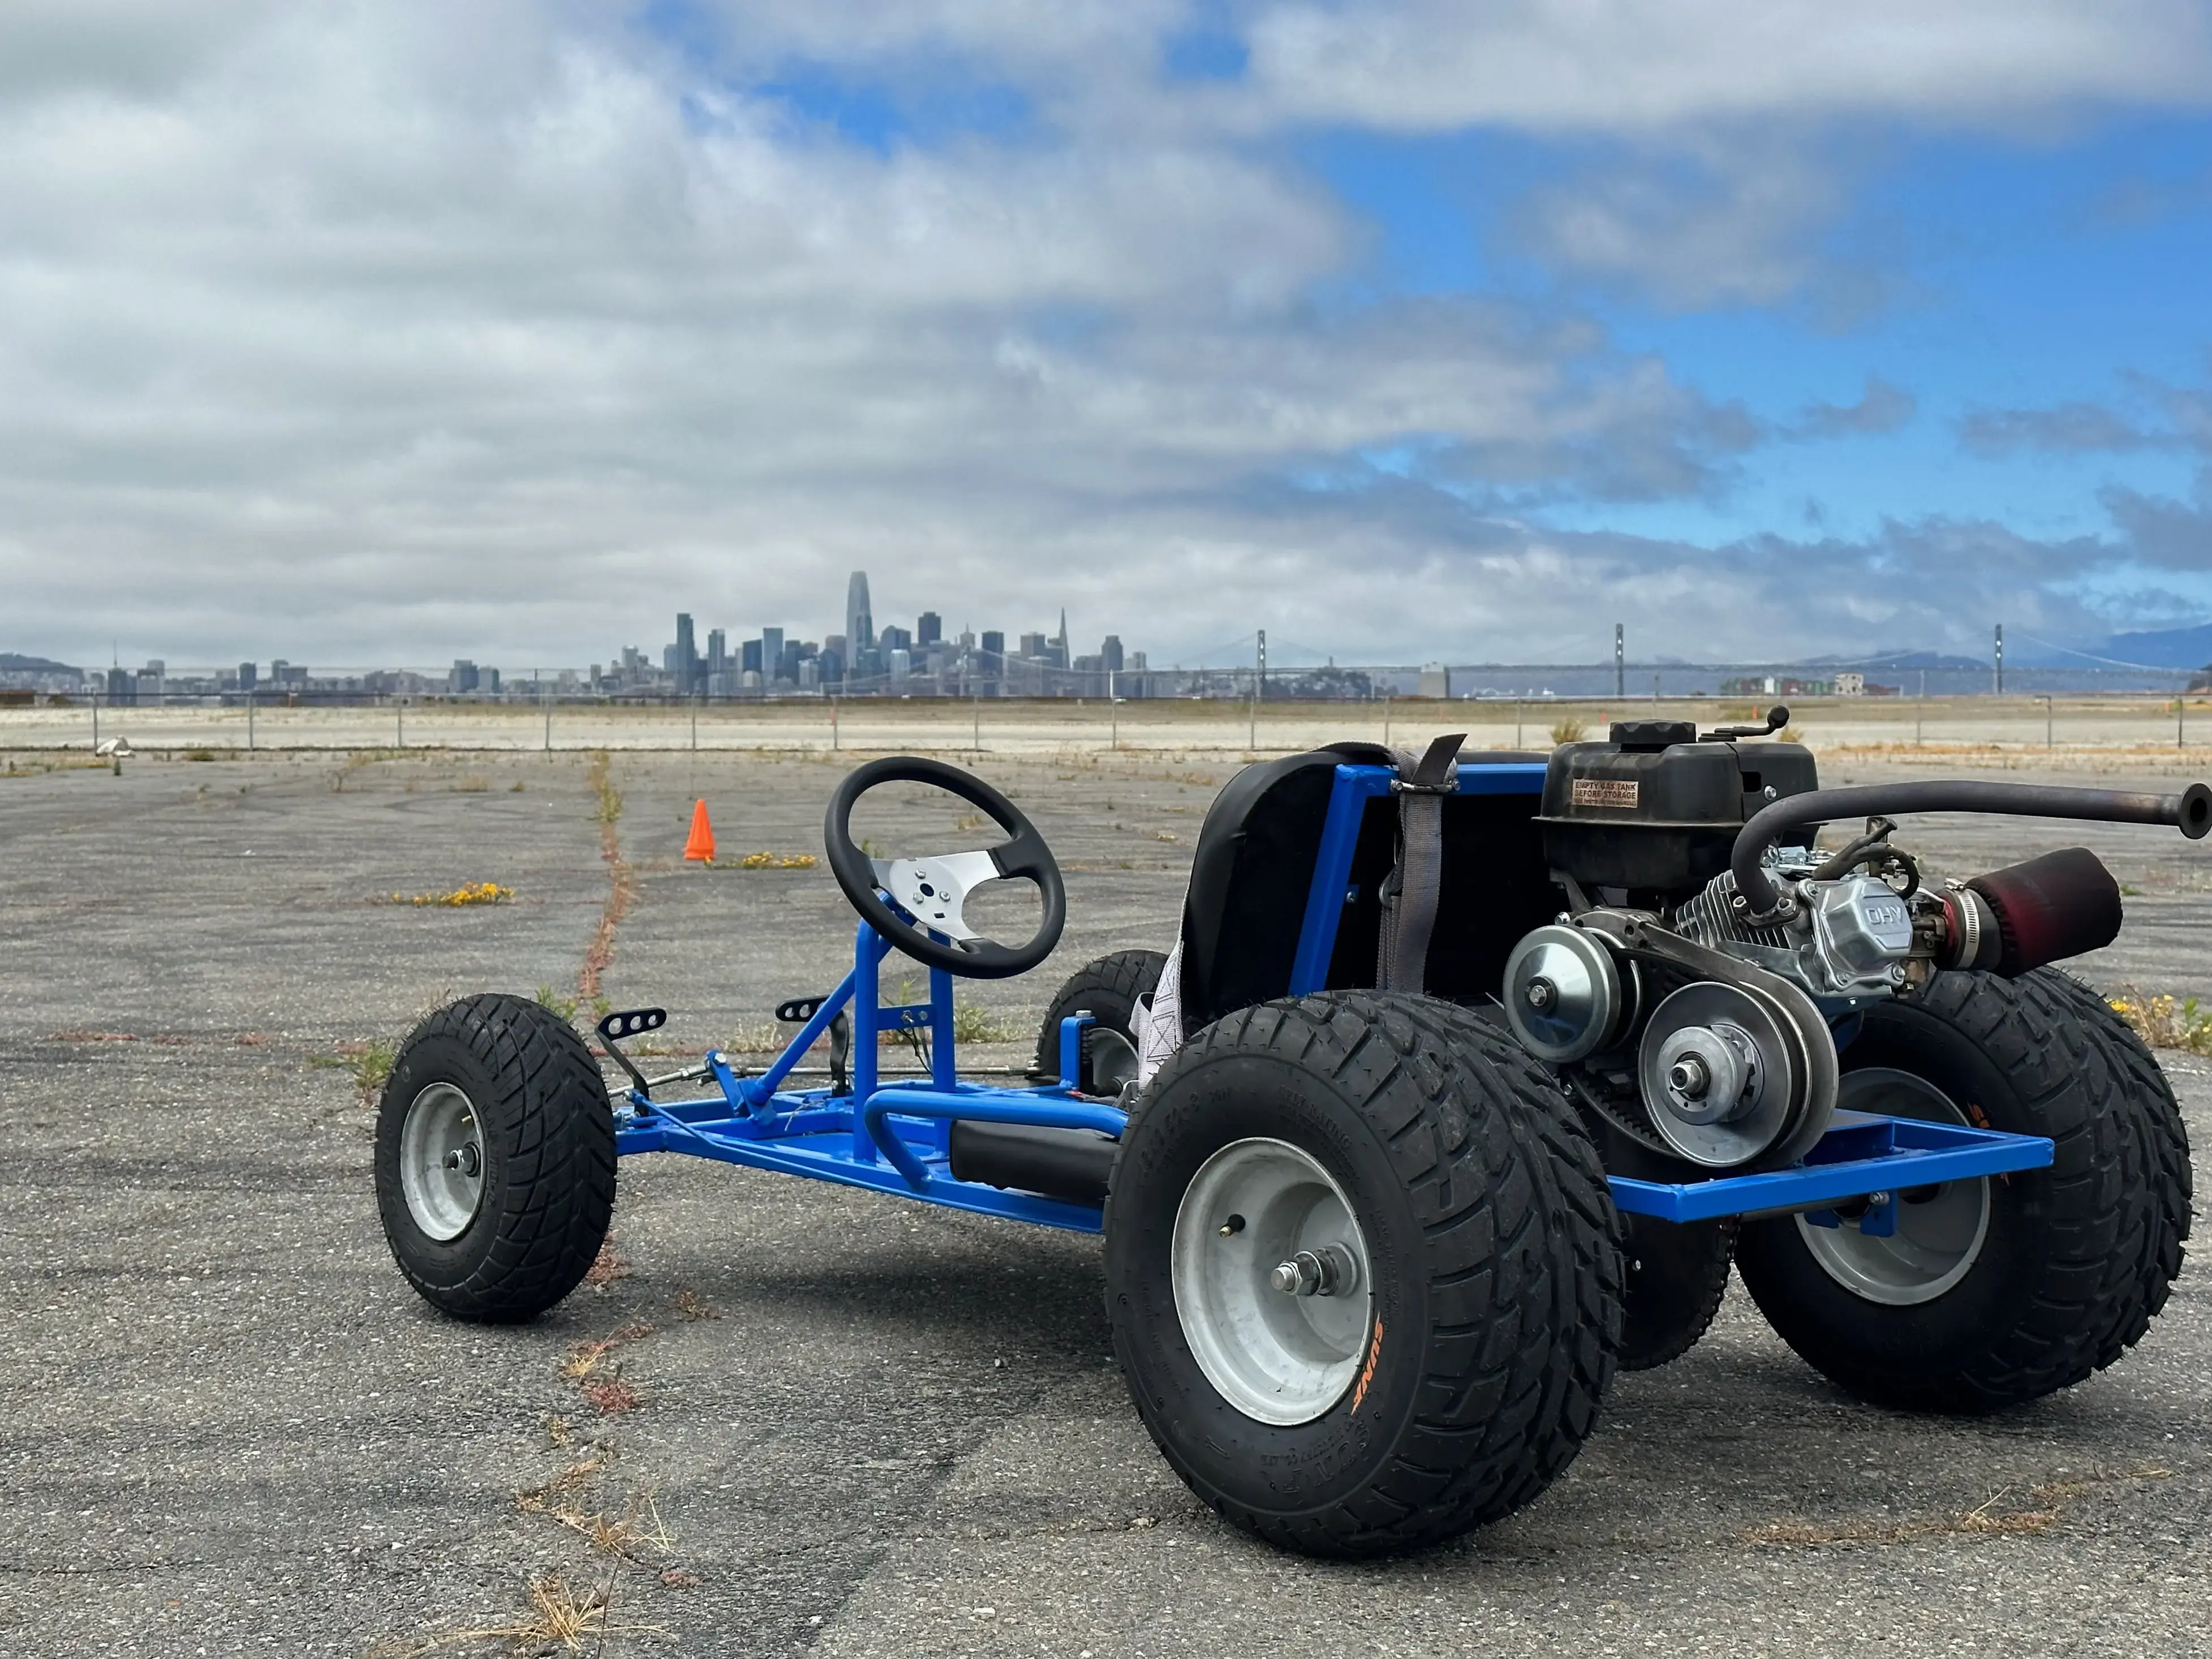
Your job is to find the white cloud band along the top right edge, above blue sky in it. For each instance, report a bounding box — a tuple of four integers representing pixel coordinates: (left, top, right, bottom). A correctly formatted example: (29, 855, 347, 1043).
(1250, 0, 2212, 135)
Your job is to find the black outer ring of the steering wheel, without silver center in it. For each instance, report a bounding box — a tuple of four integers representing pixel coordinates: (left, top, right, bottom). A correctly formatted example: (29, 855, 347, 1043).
(823, 754, 1069, 980)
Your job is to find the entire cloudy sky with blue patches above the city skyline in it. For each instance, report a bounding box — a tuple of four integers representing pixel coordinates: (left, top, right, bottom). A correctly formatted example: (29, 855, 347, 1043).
(0, 0, 2212, 671)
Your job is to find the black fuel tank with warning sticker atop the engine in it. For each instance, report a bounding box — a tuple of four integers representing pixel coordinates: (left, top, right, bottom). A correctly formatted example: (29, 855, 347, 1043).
(1537, 721, 1821, 896)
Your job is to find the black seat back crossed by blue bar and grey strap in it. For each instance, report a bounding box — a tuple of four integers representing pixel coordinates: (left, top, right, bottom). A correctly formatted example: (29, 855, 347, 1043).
(1181, 743, 1560, 1033)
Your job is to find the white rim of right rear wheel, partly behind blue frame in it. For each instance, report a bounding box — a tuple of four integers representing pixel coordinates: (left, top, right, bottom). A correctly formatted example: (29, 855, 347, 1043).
(1798, 1066, 1989, 1307)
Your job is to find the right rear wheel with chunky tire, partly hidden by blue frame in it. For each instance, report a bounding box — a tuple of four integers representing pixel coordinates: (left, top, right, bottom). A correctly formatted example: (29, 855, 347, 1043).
(1736, 973, 2179, 1411)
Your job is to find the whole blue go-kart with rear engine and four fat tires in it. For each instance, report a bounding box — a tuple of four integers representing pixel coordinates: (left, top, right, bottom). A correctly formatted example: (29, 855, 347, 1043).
(376, 725, 2212, 1555)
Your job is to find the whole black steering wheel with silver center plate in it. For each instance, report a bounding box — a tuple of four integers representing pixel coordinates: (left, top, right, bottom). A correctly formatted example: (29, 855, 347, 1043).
(823, 754, 1069, 980)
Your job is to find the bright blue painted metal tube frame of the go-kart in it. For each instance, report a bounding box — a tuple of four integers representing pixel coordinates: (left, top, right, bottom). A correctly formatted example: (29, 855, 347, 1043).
(615, 761, 2052, 1234)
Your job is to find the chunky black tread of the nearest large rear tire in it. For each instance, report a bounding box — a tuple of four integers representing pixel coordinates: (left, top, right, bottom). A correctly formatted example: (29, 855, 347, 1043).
(1108, 991, 1621, 1557)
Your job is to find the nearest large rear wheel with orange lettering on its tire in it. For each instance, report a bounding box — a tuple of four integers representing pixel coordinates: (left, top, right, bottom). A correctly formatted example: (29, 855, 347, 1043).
(1106, 991, 1621, 1557)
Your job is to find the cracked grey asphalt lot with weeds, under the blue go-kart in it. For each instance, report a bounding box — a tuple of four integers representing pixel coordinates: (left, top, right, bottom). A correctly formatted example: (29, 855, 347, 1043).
(0, 754, 2212, 1659)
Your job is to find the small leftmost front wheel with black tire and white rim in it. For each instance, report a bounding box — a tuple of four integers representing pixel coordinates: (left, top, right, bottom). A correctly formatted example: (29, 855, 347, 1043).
(376, 995, 615, 1325)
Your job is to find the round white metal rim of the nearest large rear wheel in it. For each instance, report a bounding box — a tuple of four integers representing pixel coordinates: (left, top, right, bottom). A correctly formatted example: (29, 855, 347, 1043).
(1170, 1139, 1374, 1427)
